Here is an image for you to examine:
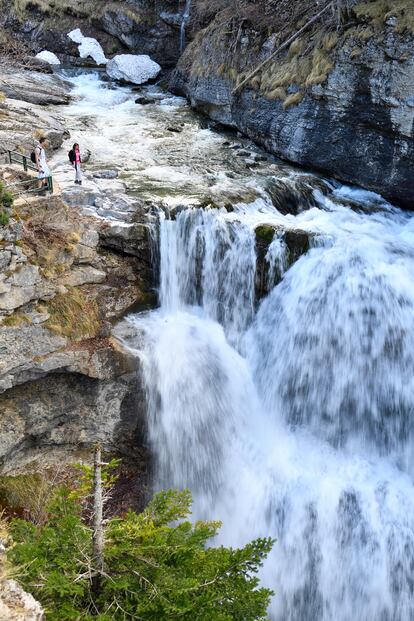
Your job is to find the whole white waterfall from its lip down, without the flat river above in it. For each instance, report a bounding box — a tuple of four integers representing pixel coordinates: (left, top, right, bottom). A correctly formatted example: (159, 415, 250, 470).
(131, 190, 414, 621)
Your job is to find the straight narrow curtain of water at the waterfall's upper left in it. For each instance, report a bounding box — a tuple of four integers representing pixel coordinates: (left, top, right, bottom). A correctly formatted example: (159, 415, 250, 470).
(160, 209, 256, 348)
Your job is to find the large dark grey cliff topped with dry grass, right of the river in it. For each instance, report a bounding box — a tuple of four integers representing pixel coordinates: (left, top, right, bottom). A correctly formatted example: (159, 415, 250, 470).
(171, 0, 414, 208)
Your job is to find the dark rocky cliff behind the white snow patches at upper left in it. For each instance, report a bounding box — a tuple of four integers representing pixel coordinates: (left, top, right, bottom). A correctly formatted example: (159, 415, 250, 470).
(0, 0, 182, 66)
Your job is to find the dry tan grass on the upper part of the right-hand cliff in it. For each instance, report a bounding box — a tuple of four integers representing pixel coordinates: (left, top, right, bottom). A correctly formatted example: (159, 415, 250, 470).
(184, 0, 414, 109)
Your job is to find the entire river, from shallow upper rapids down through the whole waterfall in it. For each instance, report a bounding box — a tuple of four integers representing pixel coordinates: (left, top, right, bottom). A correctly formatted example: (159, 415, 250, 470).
(54, 75, 414, 621)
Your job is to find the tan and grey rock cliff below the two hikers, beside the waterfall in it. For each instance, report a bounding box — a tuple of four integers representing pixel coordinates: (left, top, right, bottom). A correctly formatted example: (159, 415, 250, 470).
(0, 186, 153, 470)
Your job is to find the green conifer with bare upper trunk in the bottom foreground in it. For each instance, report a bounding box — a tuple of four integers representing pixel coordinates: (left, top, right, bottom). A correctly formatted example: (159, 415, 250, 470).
(9, 452, 273, 621)
